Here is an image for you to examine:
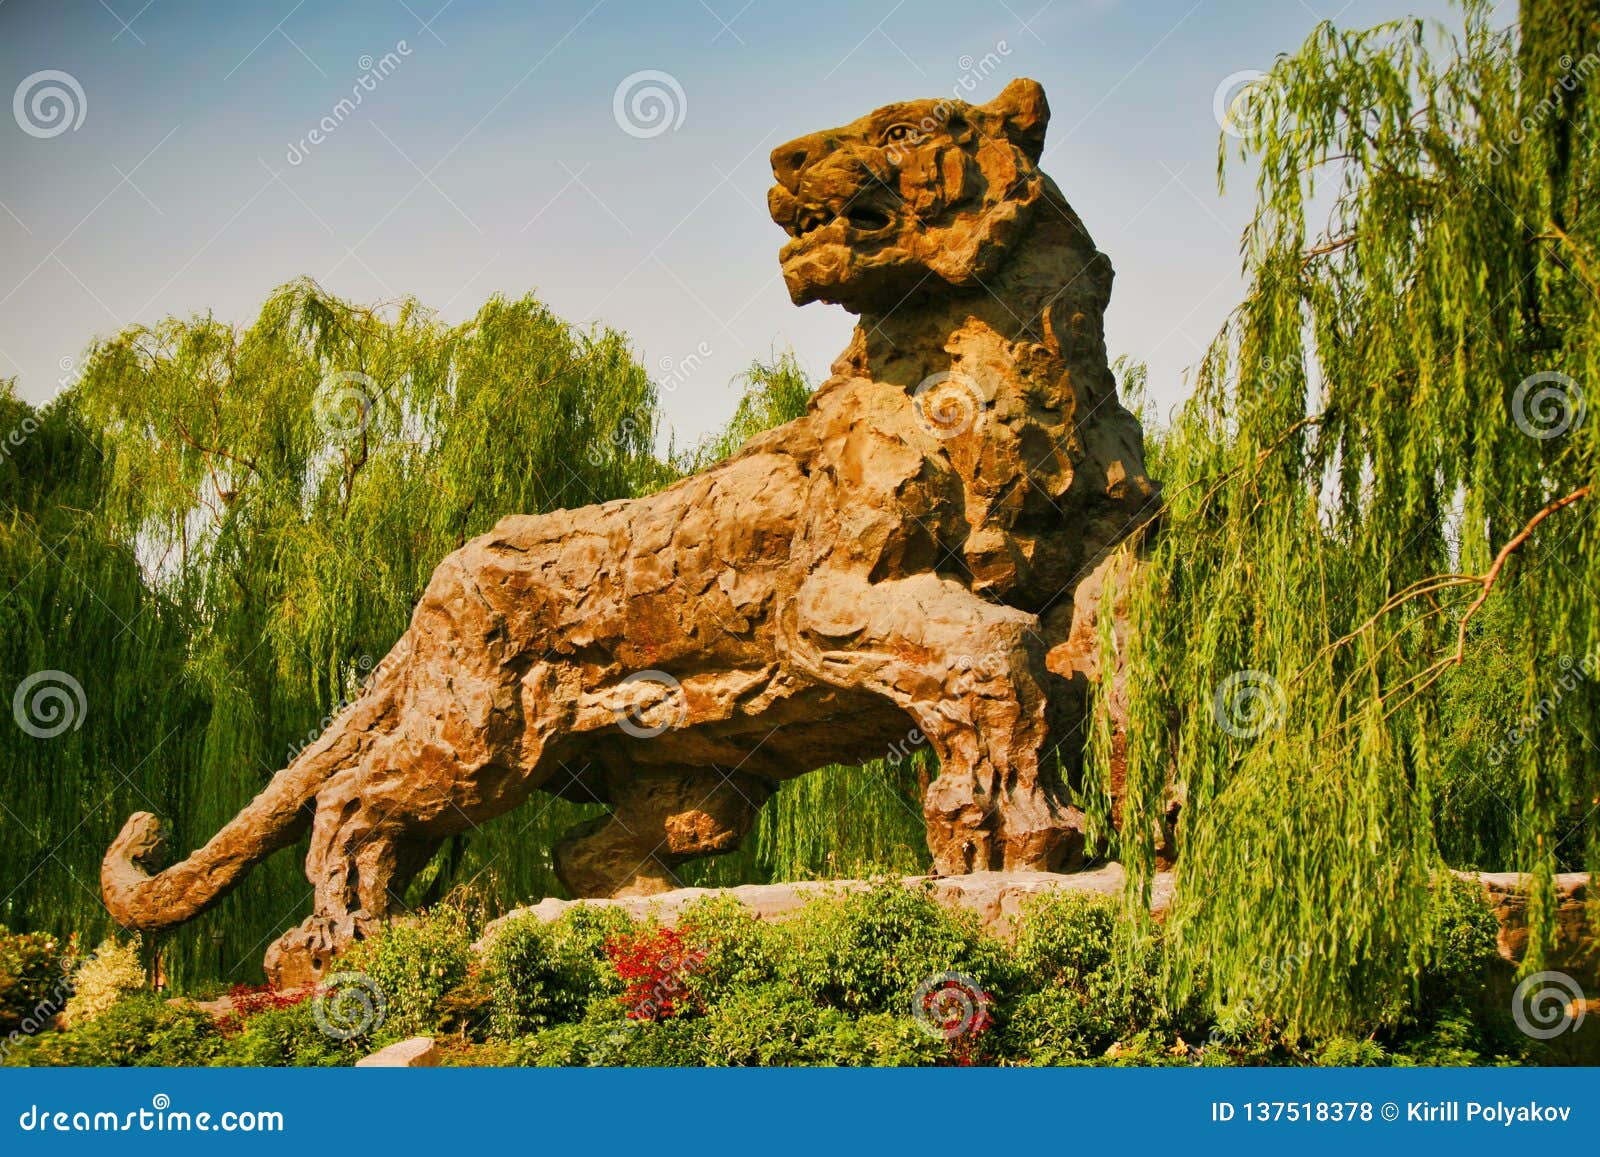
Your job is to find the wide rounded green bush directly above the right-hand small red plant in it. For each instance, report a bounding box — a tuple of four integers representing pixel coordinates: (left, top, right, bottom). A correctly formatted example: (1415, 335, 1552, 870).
(776, 880, 1018, 1015)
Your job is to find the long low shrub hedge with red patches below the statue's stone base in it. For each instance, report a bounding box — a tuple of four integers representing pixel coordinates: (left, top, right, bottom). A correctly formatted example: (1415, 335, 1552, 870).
(0, 880, 1547, 1066)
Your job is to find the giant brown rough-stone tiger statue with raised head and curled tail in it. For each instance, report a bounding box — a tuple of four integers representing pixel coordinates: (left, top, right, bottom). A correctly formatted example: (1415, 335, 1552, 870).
(101, 80, 1155, 986)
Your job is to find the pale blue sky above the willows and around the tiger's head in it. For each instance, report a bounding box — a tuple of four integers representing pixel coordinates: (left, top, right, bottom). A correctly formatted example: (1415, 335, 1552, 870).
(0, 0, 1454, 440)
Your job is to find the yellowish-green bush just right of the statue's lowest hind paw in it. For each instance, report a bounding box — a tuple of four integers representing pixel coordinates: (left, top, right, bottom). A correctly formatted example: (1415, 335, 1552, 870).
(342, 906, 477, 1045)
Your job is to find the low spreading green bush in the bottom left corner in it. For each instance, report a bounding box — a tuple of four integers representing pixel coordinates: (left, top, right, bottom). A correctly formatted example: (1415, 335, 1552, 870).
(8, 992, 224, 1067)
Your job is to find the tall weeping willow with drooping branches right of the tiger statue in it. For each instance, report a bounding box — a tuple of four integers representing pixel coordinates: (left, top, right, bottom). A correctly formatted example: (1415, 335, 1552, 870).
(1098, 0, 1600, 1031)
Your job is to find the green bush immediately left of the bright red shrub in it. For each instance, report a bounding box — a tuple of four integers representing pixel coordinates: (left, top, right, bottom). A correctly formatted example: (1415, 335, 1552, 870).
(488, 904, 632, 1040)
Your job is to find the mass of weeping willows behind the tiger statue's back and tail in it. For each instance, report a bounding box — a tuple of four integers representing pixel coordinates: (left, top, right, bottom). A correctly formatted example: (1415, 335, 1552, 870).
(0, 282, 669, 983)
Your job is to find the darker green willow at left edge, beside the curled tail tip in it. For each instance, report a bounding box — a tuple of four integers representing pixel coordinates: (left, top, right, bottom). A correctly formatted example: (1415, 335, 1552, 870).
(0, 382, 205, 960)
